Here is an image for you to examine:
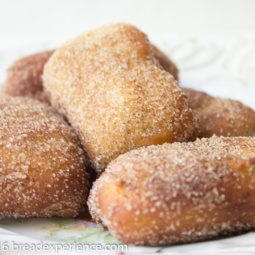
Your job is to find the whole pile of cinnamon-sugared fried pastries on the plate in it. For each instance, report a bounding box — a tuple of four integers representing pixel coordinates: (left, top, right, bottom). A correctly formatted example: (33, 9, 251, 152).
(0, 24, 255, 246)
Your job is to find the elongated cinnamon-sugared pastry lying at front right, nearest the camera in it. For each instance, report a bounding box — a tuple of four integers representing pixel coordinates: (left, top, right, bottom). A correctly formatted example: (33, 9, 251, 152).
(88, 136, 255, 246)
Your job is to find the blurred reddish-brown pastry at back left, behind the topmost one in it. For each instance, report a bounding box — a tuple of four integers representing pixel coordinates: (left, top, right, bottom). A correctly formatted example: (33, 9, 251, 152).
(2, 51, 53, 102)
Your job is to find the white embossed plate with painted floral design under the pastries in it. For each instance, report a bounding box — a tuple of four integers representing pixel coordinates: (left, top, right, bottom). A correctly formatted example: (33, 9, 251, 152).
(0, 35, 255, 255)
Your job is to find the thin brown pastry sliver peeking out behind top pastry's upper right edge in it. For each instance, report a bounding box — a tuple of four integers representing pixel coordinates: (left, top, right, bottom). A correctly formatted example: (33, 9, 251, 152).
(151, 45, 179, 81)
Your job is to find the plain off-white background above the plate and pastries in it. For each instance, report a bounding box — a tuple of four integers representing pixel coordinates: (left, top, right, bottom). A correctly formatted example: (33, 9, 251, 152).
(0, 0, 255, 50)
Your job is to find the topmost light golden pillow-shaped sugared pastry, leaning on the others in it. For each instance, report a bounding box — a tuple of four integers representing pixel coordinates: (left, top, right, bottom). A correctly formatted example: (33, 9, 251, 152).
(43, 24, 198, 173)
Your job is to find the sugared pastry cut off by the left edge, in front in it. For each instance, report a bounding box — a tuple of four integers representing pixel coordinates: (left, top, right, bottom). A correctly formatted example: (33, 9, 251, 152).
(0, 95, 88, 218)
